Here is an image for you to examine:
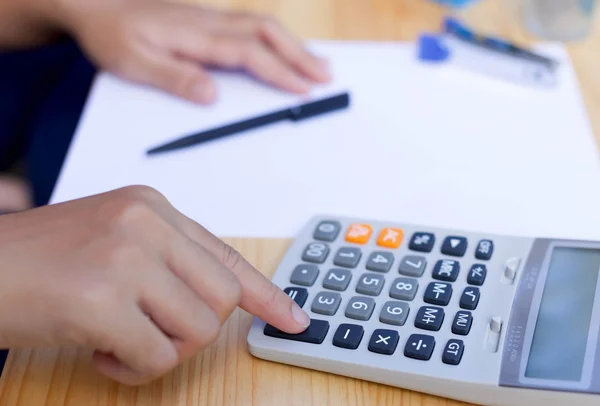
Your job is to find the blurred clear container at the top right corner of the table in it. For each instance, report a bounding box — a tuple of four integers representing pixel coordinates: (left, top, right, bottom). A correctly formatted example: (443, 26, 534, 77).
(520, 0, 598, 42)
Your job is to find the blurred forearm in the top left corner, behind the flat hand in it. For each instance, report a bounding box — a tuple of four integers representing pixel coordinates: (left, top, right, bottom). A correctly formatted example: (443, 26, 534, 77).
(0, 0, 69, 50)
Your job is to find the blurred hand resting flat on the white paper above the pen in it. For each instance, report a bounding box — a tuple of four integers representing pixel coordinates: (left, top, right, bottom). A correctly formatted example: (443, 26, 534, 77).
(58, 0, 329, 103)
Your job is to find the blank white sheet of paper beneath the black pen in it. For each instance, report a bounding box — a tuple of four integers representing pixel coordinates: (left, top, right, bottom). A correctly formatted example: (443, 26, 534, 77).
(52, 41, 600, 238)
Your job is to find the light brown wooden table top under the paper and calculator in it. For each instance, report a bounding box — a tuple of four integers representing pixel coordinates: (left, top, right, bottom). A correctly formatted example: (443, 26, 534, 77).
(0, 0, 600, 406)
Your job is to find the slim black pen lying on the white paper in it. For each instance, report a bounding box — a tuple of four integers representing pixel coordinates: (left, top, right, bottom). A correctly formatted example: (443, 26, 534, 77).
(147, 93, 350, 155)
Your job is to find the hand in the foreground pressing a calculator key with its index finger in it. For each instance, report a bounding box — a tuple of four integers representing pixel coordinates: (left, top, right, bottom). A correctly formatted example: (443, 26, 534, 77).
(0, 186, 309, 385)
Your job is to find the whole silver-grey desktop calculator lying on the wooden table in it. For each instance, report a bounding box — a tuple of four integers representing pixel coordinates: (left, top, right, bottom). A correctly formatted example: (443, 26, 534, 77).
(248, 216, 600, 406)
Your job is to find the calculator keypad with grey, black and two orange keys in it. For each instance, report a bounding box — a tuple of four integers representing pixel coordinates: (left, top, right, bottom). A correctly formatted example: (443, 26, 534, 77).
(265, 220, 504, 366)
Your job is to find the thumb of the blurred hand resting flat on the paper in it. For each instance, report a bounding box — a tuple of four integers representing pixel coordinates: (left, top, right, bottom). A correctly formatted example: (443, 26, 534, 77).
(120, 50, 216, 104)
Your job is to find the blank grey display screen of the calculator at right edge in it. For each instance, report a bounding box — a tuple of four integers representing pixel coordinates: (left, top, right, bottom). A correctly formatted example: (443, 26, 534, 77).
(525, 247, 600, 381)
